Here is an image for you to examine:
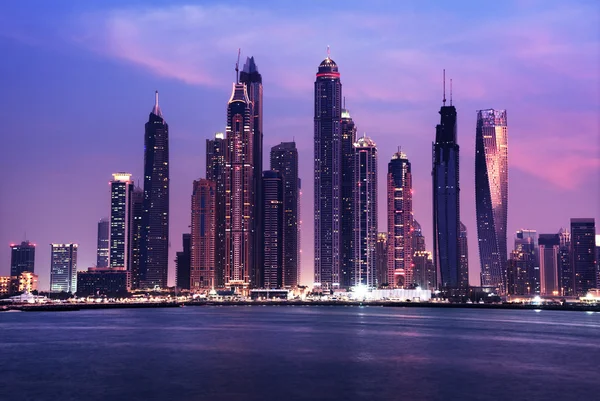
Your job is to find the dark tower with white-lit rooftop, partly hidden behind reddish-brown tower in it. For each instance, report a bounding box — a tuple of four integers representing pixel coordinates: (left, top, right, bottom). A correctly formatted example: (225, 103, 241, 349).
(206, 132, 227, 288)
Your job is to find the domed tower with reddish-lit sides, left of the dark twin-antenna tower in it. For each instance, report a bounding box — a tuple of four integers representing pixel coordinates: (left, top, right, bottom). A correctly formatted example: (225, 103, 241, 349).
(387, 151, 413, 288)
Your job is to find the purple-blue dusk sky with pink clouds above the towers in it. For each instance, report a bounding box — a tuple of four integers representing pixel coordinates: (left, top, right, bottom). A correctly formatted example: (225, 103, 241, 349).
(0, 0, 600, 289)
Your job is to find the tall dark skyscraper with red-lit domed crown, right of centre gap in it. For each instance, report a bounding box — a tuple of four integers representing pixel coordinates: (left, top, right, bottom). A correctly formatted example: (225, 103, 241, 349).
(314, 55, 342, 291)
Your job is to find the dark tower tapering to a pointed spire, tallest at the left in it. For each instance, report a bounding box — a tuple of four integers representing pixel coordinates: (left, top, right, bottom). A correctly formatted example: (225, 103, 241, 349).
(140, 91, 169, 288)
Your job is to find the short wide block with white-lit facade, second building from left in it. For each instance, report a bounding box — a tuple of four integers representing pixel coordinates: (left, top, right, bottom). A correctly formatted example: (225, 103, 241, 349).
(50, 244, 78, 294)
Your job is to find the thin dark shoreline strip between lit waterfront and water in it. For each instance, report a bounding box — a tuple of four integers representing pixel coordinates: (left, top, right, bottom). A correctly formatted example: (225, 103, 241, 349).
(0, 301, 600, 313)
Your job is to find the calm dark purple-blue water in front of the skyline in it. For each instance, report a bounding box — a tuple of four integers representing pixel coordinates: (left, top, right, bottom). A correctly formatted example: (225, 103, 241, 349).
(0, 306, 600, 401)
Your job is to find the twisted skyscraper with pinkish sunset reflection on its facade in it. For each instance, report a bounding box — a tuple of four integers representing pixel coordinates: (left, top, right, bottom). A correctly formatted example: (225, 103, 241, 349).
(475, 109, 508, 293)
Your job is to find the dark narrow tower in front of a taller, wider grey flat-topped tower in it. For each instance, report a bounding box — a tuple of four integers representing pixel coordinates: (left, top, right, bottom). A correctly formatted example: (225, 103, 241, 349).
(260, 170, 285, 289)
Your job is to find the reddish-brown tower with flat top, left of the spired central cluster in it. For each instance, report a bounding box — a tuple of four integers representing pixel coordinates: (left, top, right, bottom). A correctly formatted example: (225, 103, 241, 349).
(190, 179, 217, 291)
